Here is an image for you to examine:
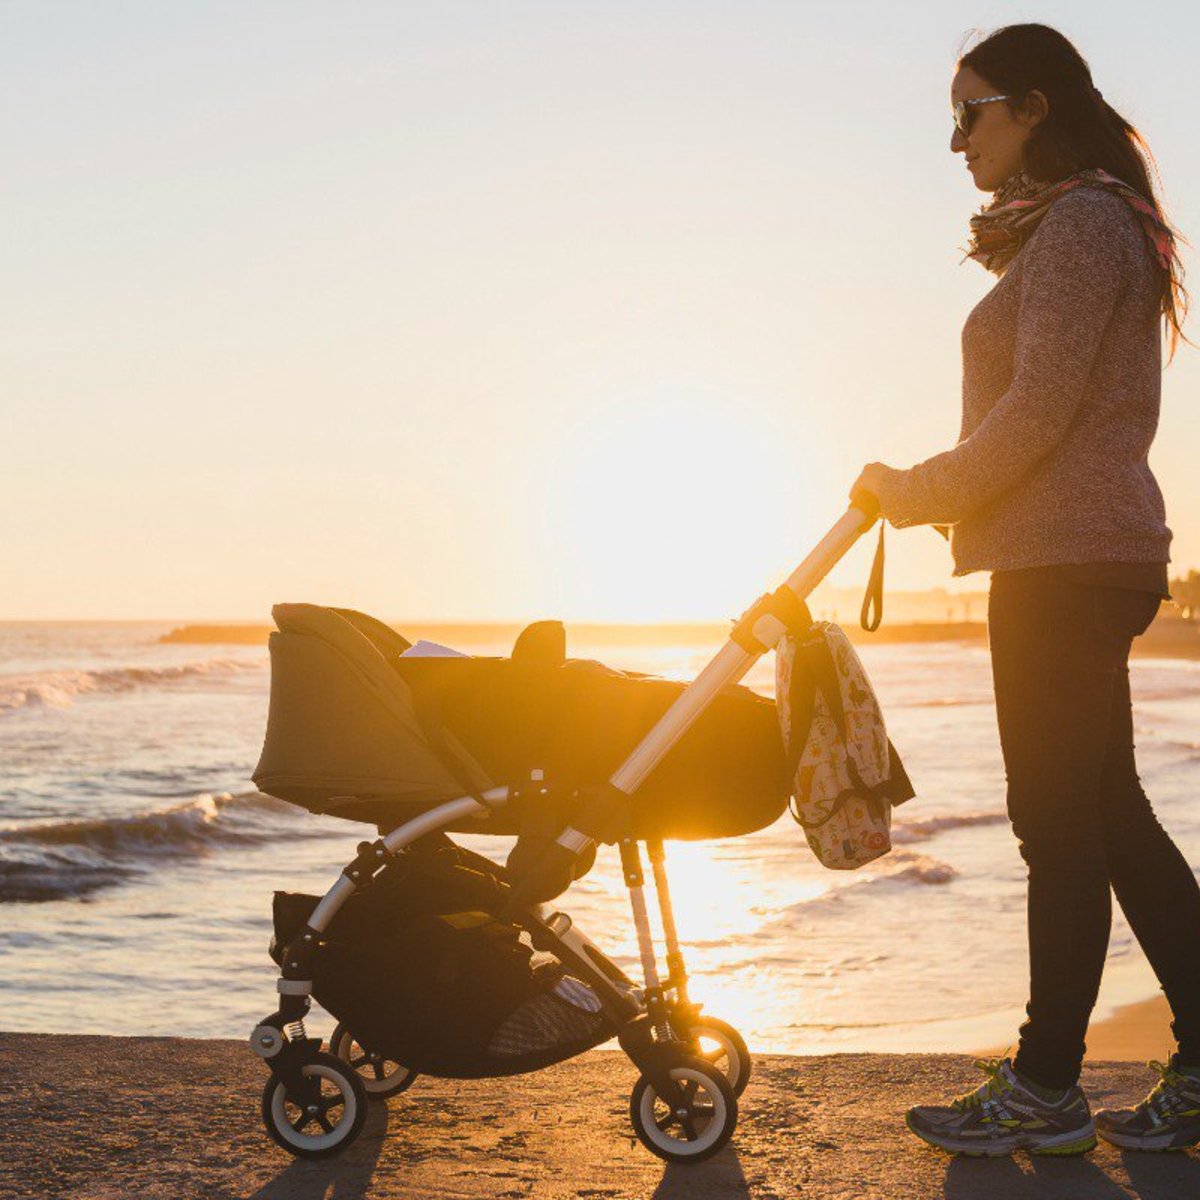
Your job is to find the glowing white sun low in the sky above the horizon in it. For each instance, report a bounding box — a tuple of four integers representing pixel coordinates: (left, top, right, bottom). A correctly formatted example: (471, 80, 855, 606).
(542, 389, 805, 622)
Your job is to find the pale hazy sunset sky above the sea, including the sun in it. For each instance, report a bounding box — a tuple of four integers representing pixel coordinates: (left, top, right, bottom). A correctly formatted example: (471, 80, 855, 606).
(0, 0, 1200, 620)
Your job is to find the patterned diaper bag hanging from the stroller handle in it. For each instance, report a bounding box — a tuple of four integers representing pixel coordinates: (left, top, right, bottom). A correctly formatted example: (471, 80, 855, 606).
(775, 620, 913, 870)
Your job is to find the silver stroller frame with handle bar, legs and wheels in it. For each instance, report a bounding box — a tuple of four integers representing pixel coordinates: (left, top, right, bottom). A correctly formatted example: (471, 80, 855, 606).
(250, 496, 878, 1162)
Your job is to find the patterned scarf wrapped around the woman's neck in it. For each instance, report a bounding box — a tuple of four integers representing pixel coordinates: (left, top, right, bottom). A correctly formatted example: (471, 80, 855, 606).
(966, 168, 1175, 275)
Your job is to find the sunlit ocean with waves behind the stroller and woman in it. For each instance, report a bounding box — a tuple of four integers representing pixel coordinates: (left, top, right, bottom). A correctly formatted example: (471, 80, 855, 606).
(0, 623, 1200, 1054)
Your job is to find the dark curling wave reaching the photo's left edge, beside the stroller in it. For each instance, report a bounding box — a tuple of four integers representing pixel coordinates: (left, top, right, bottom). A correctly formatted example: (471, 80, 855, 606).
(0, 792, 304, 904)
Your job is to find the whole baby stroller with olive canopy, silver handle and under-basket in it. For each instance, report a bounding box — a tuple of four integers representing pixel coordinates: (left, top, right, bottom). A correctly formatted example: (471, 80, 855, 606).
(250, 498, 877, 1163)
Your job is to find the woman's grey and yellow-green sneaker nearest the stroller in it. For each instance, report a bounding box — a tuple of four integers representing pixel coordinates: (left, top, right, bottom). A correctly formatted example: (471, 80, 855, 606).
(905, 1058, 1096, 1158)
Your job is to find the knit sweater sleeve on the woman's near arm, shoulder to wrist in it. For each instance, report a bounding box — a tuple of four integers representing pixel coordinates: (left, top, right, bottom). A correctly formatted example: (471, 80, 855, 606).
(886, 187, 1136, 526)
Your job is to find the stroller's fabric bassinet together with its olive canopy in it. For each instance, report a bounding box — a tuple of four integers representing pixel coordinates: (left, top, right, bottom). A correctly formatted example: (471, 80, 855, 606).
(253, 604, 788, 839)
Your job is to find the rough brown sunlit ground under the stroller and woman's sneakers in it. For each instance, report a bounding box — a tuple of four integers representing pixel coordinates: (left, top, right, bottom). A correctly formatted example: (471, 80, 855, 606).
(0, 1034, 1200, 1200)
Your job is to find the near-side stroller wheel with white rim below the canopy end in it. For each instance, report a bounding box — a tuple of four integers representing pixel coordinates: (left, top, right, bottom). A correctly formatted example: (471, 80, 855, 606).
(263, 1054, 367, 1158)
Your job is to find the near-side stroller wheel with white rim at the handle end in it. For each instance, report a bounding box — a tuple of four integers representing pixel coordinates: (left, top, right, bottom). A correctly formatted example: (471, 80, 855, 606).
(629, 1057, 738, 1163)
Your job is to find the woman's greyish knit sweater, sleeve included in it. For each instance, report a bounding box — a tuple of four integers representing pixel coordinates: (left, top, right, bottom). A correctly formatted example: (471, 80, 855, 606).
(887, 187, 1171, 575)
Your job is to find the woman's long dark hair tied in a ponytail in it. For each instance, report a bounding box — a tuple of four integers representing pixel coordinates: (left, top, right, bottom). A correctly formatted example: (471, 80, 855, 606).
(959, 24, 1188, 355)
